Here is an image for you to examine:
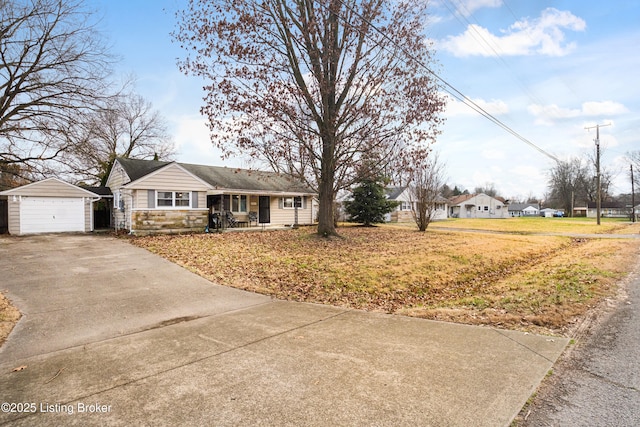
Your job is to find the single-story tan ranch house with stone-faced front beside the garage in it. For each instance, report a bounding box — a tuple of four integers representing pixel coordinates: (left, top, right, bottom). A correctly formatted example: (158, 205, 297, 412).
(107, 158, 316, 234)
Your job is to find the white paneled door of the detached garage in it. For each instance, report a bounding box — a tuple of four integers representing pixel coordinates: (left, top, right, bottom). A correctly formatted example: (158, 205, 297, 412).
(20, 197, 84, 234)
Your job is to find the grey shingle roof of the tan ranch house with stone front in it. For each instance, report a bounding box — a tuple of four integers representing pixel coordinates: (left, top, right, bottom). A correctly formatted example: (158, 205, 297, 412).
(118, 158, 316, 194)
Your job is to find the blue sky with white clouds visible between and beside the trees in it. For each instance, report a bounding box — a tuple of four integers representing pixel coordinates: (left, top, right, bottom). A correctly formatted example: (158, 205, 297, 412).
(87, 0, 640, 200)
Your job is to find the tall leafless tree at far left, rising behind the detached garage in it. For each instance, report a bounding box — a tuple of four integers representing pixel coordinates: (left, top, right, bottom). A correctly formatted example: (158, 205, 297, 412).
(0, 0, 110, 178)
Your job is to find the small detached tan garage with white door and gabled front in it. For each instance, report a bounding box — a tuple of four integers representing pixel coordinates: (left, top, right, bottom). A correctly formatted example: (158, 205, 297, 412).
(0, 178, 100, 235)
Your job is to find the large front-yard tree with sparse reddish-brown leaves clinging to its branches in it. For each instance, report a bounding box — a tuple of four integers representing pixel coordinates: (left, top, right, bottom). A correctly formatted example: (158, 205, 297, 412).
(174, 0, 445, 236)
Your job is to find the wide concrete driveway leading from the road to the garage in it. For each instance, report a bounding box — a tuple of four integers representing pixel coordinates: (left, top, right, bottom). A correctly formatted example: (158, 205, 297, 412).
(0, 235, 567, 426)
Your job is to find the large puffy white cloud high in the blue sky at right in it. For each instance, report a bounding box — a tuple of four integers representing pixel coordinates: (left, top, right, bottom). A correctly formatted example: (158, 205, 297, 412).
(439, 8, 586, 57)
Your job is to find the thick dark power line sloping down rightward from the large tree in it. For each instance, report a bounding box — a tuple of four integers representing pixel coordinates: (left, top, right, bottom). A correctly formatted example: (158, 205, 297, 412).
(317, 0, 560, 162)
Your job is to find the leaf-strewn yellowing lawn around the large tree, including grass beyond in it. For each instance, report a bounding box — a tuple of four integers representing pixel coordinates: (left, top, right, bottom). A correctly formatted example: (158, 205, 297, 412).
(131, 218, 640, 334)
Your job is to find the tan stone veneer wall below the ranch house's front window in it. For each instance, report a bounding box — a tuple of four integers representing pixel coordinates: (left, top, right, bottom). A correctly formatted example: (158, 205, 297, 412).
(131, 210, 209, 234)
